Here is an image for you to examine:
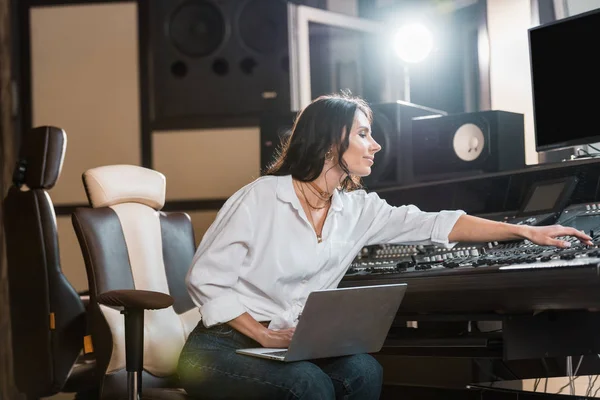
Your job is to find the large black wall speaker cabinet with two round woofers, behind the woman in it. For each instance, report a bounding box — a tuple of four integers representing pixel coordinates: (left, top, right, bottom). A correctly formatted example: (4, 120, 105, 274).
(148, 0, 290, 129)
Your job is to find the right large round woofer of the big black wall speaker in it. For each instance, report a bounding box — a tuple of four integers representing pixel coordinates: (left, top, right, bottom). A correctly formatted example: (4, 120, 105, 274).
(238, 0, 287, 54)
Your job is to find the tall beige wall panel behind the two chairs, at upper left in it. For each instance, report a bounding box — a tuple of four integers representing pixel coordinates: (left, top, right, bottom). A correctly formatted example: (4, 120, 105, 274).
(30, 2, 141, 205)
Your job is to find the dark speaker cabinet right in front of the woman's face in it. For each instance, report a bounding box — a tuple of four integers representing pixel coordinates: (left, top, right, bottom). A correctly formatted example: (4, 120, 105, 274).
(363, 101, 446, 189)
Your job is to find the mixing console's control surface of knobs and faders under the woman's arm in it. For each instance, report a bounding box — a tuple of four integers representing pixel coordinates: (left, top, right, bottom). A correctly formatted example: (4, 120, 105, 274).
(347, 203, 600, 276)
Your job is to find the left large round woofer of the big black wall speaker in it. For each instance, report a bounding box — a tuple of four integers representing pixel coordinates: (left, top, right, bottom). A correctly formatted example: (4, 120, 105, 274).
(168, 1, 225, 57)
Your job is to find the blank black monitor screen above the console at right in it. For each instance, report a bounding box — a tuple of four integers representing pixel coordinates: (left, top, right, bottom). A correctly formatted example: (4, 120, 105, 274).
(529, 9, 600, 151)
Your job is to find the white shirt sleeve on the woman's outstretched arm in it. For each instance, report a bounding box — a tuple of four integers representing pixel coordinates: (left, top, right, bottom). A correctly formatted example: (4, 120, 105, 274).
(365, 193, 465, 248)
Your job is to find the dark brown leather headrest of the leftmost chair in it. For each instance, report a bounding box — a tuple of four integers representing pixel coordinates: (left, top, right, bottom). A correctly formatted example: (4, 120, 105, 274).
(13, 126, 67, 189)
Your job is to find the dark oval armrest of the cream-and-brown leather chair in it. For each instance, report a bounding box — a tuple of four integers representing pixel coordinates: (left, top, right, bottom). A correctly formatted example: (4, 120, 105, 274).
(97, 289, 175, 310)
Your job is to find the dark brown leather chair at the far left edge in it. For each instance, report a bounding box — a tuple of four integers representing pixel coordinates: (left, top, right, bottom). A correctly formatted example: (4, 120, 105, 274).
(3, 126, 98, 399)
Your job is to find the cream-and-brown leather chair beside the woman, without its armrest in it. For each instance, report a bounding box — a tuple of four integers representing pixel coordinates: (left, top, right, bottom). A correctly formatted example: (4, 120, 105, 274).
(72, 165, 200, 398)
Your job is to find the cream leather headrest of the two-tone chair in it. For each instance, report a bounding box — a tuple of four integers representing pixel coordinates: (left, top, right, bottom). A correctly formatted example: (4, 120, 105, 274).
(83, 165, 167, 211)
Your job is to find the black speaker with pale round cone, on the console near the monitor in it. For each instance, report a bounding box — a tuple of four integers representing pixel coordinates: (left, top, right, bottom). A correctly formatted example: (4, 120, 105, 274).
(412, 111, 525, 181)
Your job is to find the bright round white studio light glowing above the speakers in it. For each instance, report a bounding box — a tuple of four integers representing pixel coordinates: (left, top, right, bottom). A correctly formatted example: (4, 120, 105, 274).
(394, 24, 433, 63)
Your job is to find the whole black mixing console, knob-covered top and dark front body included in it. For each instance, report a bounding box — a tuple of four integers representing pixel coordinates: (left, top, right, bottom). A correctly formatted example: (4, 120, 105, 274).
(340, 199, 600, 350)
